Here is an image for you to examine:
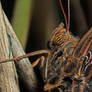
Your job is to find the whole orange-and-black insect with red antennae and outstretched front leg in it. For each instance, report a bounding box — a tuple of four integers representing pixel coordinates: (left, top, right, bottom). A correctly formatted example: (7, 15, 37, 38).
(1, 0, 92, 92)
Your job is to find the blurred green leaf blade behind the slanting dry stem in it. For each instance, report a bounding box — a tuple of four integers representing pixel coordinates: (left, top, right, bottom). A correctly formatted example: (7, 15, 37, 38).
(12, 0, 33, 48)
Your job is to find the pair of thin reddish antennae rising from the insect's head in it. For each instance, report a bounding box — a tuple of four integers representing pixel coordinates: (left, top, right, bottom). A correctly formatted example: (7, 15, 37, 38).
(59, 0, 70, 31)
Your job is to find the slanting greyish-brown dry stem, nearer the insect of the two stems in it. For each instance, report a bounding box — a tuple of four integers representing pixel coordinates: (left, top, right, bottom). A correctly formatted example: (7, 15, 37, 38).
(3, 7, 38, 92)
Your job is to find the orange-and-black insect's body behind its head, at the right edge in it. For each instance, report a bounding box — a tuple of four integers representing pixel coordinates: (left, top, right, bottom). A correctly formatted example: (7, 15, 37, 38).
(51, 29, 92, 92)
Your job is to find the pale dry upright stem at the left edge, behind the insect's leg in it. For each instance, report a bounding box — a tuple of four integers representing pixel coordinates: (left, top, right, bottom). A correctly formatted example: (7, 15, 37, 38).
(0, 3, 20, 92)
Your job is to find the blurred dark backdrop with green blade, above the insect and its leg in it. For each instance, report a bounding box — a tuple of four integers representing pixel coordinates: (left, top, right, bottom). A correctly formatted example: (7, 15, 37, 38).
(1, 0, 92, 91)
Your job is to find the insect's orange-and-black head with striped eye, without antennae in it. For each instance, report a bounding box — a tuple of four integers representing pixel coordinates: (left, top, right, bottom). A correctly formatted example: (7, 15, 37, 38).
(43, 25, 78, 90)
